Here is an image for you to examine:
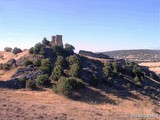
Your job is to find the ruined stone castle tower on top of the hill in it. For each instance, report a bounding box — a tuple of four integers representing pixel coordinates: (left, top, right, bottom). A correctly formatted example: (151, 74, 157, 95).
(51, 35, 63, 46)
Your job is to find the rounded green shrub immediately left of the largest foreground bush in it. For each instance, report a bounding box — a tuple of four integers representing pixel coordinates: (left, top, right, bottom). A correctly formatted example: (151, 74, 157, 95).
(36, 75, 50, 86)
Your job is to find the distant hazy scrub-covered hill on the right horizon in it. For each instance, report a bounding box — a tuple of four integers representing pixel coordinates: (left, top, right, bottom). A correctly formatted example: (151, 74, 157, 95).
(102, 49, 160, 61)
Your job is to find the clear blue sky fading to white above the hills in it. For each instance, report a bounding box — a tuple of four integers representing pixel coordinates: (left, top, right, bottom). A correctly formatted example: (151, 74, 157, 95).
(0, 0, 160, 52)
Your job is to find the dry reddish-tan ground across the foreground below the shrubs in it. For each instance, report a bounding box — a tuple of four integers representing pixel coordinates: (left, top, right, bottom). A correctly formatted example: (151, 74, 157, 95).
(0, 88, 160, 120)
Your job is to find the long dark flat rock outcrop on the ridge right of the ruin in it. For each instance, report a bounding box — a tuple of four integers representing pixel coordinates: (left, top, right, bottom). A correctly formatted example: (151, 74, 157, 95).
(78, 50, 109, 59)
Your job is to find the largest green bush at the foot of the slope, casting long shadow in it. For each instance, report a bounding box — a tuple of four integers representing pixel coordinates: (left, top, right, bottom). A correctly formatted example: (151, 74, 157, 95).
(53, 77, 84, 97)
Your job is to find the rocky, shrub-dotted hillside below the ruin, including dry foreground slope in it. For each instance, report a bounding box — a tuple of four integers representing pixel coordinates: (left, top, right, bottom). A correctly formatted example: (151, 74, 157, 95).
(0, 40, 160, 120)
